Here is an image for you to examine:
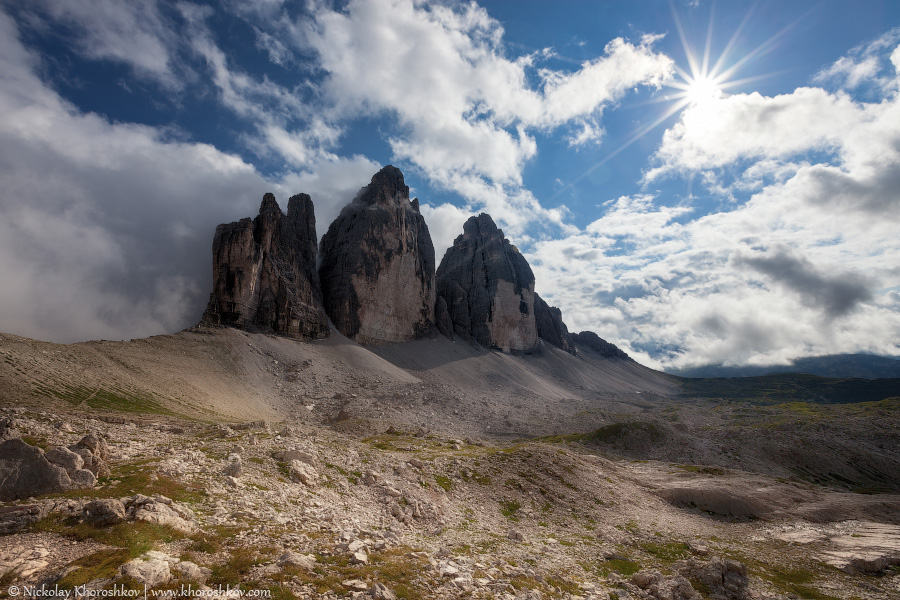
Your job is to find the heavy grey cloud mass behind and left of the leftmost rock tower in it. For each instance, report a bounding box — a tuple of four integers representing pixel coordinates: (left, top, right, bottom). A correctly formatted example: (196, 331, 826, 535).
(0, 12, 376, 341)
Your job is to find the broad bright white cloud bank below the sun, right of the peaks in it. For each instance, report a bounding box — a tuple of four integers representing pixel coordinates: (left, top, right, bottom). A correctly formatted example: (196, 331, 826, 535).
(528, 35, 900, 367)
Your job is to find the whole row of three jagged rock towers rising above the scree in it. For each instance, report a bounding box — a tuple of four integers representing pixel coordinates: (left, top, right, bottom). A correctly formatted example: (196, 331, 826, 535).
(203, 165, 612, 357)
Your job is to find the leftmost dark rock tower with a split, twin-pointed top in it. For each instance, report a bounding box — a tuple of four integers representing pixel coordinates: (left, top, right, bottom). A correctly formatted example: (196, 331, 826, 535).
(203, 194, 328, 338)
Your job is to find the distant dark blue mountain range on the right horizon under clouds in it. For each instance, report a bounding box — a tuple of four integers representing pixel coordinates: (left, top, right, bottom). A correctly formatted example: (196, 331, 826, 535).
(667, 354, 900, 379)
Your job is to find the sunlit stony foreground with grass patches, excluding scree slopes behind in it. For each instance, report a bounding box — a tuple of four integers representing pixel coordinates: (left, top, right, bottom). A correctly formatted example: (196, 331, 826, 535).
(0, 409, 900, 599)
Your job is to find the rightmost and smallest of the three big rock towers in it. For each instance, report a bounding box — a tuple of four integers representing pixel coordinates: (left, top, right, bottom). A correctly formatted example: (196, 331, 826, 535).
(437, 213, 538, 352)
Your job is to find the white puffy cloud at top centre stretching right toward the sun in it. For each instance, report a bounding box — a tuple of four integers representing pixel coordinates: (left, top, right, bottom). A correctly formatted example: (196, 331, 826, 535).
(299, 0, 673, 234)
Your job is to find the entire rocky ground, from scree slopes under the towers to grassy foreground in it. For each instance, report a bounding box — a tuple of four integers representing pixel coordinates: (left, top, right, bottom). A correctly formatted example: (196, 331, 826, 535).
(0, 330, 900, 600)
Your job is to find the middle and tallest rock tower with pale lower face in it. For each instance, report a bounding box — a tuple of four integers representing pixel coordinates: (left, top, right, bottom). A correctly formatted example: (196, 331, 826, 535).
(319, 165, 435, 344)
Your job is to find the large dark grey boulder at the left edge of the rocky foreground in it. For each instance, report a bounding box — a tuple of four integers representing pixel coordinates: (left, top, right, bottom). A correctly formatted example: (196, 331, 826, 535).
(0, 438, 73, 501)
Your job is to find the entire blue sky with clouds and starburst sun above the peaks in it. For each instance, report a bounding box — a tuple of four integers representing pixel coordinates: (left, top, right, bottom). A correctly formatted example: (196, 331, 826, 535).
(0, 0, 900, 369)
